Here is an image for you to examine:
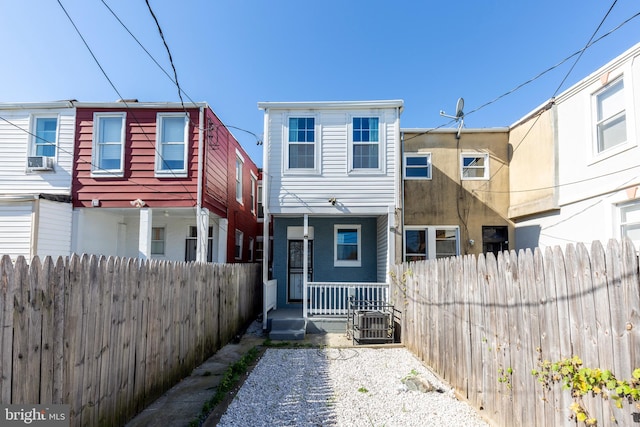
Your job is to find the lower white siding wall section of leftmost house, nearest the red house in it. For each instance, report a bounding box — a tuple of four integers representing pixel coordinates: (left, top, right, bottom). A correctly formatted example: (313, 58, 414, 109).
(37, 200, 72, 257)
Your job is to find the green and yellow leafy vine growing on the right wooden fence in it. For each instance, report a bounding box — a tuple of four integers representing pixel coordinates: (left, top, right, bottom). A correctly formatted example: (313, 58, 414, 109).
(531, 356, 640, 426)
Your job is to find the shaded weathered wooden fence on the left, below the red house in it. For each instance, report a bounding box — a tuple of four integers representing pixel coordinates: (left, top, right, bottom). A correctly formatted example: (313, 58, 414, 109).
(0, 255, 261, 426)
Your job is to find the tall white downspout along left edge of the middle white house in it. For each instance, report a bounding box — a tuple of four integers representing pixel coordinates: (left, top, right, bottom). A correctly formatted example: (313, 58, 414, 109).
(262, 109, 277, 330)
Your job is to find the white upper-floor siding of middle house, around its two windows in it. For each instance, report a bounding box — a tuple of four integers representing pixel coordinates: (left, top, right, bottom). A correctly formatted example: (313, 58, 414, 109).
(267, 109, 399, 214)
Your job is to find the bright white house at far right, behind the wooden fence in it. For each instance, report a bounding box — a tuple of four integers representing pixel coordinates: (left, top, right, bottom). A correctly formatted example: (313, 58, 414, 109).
(516, 44, 640, 249)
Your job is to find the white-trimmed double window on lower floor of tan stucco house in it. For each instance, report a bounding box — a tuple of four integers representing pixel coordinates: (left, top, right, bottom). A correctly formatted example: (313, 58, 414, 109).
(404, 226, 460, 262)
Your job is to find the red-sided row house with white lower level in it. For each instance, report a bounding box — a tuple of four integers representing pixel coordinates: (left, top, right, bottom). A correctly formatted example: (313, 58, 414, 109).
(71, 100, 258, 262)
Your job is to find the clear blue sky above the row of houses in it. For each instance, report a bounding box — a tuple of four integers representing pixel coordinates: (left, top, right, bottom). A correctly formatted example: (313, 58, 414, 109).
(0, 0, 640, 166)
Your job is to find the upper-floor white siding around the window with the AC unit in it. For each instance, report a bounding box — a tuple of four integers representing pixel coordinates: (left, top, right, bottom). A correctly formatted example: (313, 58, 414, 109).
(0, 108, 75, 194)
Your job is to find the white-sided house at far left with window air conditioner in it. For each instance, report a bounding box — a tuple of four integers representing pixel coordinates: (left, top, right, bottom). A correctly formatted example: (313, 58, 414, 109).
(0, 101, 76, 261)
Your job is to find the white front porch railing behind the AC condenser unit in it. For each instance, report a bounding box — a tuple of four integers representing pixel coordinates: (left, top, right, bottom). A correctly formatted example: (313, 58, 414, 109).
(303, 282, 389, 318)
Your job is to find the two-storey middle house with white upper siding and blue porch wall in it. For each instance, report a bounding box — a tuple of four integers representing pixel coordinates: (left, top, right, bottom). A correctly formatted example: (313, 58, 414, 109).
(258, 100, 403, 320)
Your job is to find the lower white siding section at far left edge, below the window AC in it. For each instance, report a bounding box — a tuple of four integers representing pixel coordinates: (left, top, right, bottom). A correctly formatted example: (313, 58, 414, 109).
(0, 201, 33, 262)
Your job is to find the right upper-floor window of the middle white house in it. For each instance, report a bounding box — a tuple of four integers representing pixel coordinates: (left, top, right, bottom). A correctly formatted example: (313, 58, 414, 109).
(352, 117, 380, 170)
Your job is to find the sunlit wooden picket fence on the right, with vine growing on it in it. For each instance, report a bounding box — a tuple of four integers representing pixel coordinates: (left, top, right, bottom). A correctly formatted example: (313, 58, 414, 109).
(391, 240, 640, 426)
